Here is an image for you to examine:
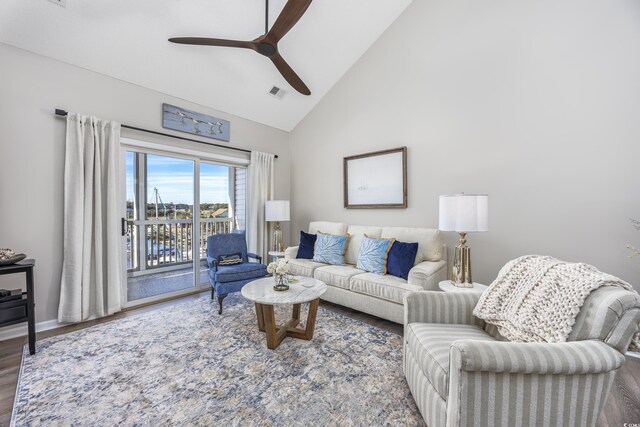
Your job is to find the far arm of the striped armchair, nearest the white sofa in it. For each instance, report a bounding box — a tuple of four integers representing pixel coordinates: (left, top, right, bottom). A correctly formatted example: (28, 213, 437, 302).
(404, 291, 484, 327)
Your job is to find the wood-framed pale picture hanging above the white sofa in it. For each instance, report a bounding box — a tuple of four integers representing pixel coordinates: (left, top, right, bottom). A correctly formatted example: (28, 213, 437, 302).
(343, 147, 407, 209)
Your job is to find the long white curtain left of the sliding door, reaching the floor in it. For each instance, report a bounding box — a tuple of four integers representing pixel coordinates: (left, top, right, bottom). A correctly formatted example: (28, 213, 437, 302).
(58, 114, 125, 322)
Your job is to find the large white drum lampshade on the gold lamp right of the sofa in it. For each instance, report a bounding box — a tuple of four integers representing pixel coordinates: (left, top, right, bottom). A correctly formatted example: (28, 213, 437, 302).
(439, 194, 489, 233)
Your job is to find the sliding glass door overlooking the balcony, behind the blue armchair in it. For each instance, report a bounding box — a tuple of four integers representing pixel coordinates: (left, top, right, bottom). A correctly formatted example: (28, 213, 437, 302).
(125, 145, 244, 304)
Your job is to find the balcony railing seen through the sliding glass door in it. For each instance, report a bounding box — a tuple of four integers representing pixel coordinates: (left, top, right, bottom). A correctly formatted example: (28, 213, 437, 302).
(127, 218, 233, 272)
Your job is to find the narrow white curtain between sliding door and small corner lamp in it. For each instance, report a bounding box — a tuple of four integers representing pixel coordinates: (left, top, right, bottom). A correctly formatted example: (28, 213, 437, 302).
(247, 151, 274, 262)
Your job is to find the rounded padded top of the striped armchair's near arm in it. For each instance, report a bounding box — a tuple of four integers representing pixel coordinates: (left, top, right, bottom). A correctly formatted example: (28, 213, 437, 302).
(450, 340, 625, 375)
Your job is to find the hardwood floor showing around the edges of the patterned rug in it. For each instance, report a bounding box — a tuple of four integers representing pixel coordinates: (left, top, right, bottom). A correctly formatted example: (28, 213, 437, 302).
(0, 291, 640, 427)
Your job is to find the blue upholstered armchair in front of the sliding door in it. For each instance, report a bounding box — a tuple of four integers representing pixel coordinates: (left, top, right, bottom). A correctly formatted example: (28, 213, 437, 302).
(207, 232, 268, 314)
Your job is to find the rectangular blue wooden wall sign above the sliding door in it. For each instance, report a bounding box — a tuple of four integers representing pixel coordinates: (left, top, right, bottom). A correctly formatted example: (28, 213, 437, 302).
(162, 104, 231, 142)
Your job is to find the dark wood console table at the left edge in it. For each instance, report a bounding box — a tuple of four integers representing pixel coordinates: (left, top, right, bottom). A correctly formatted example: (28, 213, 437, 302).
(0, 259, 36, 354)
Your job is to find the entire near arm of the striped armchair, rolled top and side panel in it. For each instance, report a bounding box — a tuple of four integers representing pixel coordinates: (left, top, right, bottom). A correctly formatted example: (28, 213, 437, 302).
(446, 340, 624, 426)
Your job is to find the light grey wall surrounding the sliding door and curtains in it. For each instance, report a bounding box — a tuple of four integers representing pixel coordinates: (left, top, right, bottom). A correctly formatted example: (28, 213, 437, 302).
(0, 44, 290, 322)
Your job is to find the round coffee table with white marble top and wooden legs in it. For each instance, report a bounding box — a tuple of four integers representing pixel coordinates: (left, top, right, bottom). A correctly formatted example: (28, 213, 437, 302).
(241, 276, 327, 350)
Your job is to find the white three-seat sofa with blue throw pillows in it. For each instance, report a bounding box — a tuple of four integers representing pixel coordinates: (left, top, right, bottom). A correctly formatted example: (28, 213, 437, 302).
(285, 221, 447, 323)
